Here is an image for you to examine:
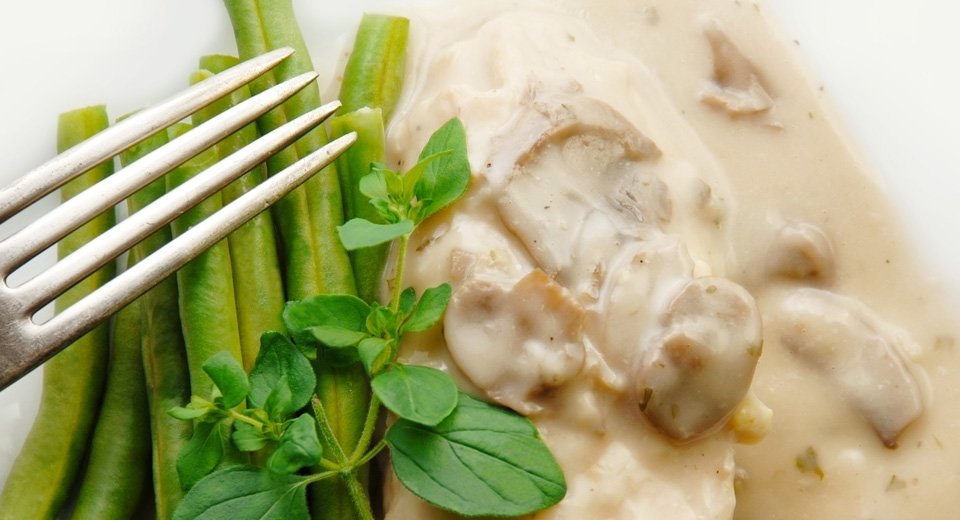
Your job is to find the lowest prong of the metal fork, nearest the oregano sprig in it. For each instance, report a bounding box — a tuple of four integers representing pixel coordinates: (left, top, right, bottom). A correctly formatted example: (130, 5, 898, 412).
(0, 132, 356, 389)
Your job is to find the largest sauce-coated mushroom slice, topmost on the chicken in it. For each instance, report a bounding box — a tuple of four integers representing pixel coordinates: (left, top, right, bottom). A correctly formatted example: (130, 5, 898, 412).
(497, 97, 671, 289)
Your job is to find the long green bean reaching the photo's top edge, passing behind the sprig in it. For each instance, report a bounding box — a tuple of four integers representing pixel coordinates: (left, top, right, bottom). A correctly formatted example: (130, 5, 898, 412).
(224, 0, 369, 519)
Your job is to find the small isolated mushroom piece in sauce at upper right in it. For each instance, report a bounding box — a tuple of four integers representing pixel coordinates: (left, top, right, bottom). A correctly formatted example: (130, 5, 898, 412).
(700, 22, 774, 116)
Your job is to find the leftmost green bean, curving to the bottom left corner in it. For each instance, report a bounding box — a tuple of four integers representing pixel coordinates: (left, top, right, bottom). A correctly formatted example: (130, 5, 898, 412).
(0, 106, 116, 520)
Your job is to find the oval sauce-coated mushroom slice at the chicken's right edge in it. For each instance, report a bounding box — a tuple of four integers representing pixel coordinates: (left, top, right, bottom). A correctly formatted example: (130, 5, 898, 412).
(635, 277, 763, 441)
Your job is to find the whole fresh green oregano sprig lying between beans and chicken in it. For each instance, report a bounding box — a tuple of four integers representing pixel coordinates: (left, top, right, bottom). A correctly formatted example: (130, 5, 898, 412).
(171, 119, 566, 520)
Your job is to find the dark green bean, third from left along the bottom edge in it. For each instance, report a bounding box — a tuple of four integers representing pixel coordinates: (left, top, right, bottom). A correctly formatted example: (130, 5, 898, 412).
(120, 123, 193, 520)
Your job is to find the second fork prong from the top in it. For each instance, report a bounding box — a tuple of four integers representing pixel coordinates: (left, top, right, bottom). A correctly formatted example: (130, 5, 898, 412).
(0, 72, 317, 275)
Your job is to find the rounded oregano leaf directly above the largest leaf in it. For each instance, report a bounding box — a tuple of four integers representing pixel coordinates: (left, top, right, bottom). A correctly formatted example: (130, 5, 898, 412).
(370, 364, 458, 425)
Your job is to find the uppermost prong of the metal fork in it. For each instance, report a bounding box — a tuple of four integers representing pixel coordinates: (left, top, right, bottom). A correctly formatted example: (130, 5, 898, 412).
(0, 48, 293, 223)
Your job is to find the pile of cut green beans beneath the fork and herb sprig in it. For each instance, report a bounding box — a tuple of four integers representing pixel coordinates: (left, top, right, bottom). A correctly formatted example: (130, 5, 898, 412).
(0, 0, 408, 520)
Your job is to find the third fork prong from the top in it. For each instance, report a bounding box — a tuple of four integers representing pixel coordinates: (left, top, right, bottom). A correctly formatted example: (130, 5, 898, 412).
(12, 101, 340, 314)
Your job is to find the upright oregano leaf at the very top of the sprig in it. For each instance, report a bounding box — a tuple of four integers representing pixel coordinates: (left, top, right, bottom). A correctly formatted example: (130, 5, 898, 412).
(414, 118, 470, 223)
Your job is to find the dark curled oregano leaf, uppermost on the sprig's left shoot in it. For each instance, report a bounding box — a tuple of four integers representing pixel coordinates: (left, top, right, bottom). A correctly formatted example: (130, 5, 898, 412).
(249, 332, 317, 420)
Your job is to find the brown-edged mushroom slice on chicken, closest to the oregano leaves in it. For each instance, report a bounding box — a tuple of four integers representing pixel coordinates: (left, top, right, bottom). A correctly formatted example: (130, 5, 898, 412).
(444, 269, 585, 414)
